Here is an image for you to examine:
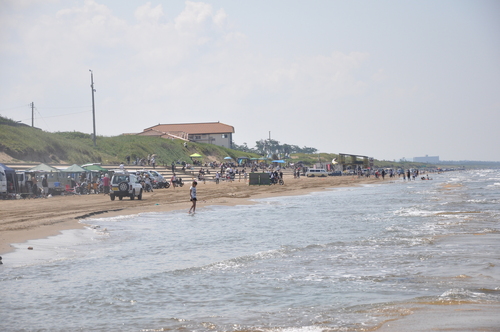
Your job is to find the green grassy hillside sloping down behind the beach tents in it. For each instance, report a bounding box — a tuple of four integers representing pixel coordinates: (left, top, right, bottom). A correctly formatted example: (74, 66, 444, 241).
(0, 117, 258, 165)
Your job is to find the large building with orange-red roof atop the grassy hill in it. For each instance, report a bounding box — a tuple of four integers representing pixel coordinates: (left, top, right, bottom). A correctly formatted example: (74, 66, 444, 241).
(137, 122, 234, 148)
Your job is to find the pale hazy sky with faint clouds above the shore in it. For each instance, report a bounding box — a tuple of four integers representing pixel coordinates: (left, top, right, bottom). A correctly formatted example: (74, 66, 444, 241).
(0, 0, 500, 161)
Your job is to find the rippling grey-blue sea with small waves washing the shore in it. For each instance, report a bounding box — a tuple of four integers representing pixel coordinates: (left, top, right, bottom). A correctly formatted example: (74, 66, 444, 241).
(0, 170, 500, 332)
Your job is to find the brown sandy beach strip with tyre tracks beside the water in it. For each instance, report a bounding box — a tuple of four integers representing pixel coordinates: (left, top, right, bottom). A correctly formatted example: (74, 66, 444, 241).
(0, 175, 386, 254)
